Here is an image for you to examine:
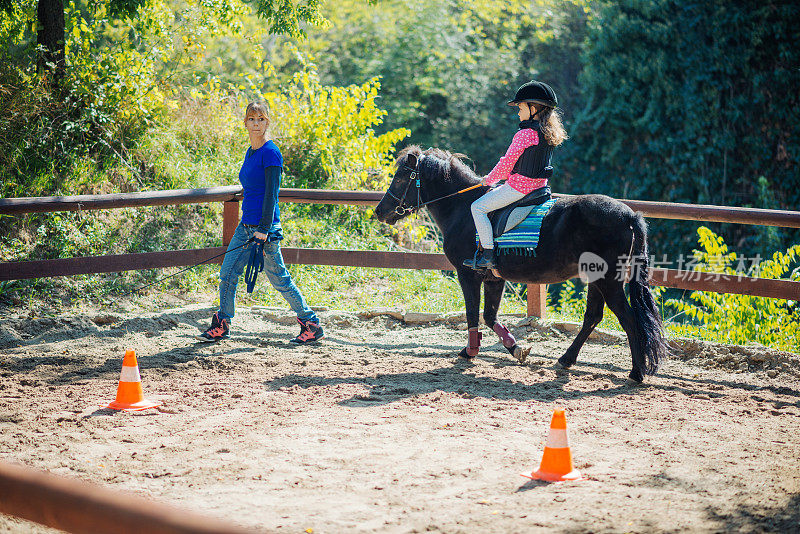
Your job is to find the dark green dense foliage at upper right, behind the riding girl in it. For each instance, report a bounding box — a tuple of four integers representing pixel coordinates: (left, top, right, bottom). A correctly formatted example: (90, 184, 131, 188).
(561, 0, 800, 252)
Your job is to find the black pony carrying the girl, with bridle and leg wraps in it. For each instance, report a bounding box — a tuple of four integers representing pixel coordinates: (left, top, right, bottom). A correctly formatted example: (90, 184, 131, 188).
(375, 146, 667, 382)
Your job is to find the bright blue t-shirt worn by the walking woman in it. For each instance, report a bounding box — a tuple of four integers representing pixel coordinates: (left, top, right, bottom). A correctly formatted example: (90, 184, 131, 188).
(239, 141, 283, 228)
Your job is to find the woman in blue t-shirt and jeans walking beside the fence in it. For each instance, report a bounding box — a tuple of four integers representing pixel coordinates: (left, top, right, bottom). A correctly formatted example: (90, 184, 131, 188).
(197, 102, 323, 343)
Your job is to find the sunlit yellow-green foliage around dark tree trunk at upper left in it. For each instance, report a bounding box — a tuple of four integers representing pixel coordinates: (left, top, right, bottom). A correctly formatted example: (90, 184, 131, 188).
(0, 1, 169, 196)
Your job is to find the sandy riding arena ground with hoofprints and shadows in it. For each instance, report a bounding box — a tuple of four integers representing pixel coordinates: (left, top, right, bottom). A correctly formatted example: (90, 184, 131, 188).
(0, 306, 800, 533)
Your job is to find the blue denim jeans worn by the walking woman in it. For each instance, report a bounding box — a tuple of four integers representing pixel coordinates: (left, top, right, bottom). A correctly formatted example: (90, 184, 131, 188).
(219, 223, 319, 323)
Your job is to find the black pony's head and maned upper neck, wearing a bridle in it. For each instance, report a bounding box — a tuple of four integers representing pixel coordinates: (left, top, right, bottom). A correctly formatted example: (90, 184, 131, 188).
(375, 145, 477, 224)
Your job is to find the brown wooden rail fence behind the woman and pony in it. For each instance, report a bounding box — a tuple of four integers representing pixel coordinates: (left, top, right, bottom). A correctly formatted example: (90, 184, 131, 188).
(0, 186, 800, 317)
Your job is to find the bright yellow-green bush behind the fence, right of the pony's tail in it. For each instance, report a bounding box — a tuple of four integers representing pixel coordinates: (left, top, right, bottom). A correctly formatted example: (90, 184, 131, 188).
(667, 226, 800, 352)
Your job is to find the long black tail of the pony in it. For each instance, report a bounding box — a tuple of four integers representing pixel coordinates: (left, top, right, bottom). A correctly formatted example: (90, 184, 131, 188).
(629, 213, 669, 375)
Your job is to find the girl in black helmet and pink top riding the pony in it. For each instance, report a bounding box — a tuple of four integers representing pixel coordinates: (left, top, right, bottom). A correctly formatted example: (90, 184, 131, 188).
(464, 81, 567, 269)
